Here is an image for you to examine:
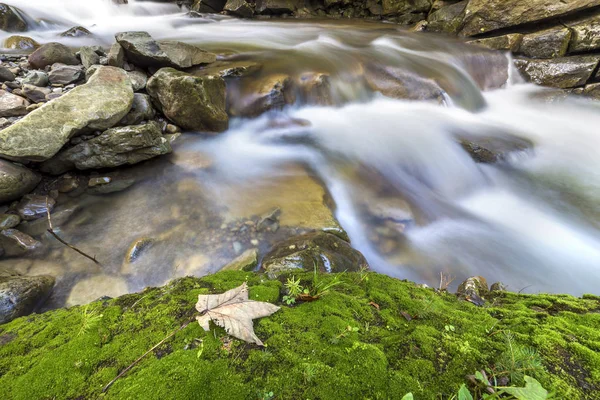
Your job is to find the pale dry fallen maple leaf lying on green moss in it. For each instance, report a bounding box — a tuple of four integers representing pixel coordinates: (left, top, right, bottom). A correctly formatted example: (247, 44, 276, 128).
(196, 282, 280, 346)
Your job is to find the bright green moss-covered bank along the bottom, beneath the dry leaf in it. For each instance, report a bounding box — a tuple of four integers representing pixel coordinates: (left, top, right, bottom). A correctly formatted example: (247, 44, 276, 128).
(0, 272, 600, 400)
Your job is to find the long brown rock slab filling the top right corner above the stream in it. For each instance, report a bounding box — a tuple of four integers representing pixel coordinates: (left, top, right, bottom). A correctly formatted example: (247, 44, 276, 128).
(460, 0, 600, 36)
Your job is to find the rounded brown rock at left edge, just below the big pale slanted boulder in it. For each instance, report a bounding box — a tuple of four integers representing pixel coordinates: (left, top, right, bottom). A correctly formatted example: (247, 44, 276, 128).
(0, 160, 41, 203)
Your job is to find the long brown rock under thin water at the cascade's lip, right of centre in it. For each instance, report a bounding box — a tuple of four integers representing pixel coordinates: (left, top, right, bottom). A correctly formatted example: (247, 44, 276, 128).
(365, 64, 444, 102)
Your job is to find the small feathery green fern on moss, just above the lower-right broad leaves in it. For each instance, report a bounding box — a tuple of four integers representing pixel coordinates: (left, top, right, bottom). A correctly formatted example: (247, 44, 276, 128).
(495, 331, 544, 385)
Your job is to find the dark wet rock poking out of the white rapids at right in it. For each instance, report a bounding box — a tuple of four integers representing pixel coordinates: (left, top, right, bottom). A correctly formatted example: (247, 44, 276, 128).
(459, 134, 533, 164)
